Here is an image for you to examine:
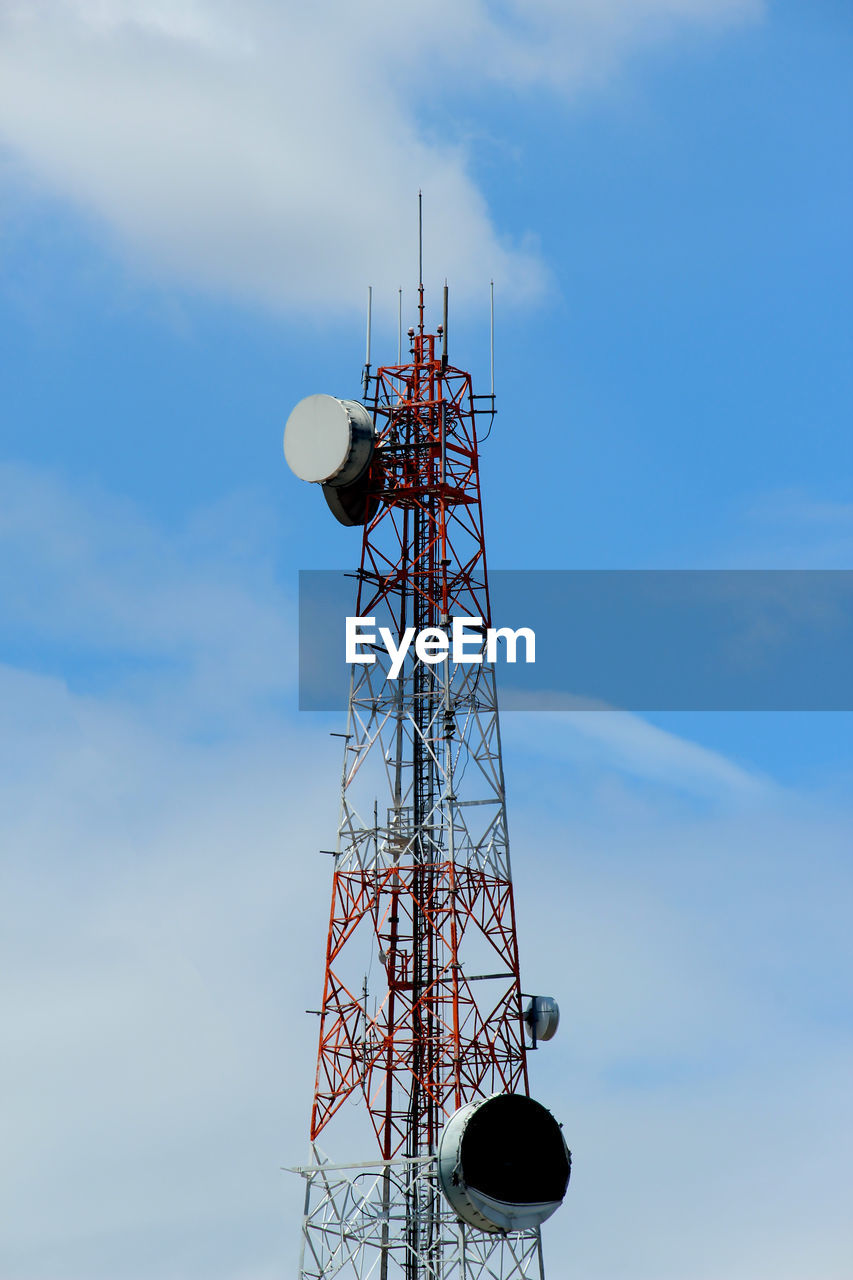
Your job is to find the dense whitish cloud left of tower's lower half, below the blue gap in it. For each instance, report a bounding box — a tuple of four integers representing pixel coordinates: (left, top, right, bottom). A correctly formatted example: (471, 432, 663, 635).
(0, 669, 326, 1280)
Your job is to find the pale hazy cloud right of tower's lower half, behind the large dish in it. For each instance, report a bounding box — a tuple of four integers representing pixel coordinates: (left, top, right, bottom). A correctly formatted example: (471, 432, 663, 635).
(510, 788, 853, 1280)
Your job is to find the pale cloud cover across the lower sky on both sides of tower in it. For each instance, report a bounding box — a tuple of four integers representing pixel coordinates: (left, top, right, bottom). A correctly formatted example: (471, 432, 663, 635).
(0, 468, 850, 1280)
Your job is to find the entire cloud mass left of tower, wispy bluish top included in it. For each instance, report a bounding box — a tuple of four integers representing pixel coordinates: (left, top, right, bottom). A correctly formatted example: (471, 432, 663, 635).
(0, 465, 339, 1280)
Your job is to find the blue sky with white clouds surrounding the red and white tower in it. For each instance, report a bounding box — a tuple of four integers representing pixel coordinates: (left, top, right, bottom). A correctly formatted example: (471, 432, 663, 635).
(0, 0, 853, 1280)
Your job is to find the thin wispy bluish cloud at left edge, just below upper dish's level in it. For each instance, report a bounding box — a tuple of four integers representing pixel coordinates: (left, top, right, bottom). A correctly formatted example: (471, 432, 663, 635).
(0, 463, 296, 714)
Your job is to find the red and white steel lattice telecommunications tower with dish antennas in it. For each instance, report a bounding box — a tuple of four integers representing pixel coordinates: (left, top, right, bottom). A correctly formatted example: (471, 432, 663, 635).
(284, 275, 571, 1280)
